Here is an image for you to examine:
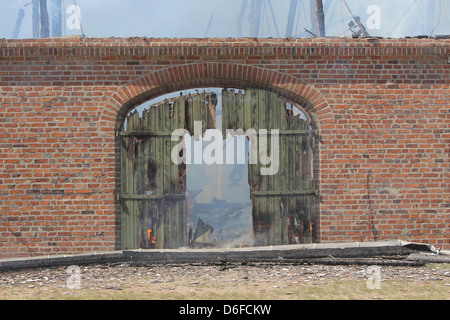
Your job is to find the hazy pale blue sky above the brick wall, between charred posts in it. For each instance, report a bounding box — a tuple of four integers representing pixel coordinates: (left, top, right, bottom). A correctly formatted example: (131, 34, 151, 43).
(0, 0, 450, 39)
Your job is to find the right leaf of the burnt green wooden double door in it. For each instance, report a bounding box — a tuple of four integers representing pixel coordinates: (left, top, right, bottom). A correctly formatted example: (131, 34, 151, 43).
(222, 89, 316, 246)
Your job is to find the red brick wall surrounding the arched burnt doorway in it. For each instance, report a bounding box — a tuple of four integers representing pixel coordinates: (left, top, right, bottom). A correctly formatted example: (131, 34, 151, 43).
(0, 38, 450, 257)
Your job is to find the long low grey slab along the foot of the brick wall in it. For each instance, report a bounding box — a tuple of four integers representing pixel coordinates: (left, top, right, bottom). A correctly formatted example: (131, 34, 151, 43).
(0, 240, 437, 271)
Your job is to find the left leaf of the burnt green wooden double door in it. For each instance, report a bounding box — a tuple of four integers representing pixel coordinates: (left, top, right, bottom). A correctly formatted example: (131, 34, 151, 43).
(118, 93, 215, 249)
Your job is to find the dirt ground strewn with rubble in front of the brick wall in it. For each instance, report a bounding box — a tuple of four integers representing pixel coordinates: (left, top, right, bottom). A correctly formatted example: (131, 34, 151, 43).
(0, 263, 450, 300)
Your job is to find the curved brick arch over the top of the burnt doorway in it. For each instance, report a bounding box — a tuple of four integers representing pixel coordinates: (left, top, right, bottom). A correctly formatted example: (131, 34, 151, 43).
(99, 62, 333, 129)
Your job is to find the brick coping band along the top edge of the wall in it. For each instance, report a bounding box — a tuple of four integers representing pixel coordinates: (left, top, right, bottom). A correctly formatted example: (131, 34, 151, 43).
(0, 37, 450, 60)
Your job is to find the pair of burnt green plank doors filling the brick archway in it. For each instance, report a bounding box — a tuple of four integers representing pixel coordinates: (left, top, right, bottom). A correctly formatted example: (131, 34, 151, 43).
(118, 88, 316, 249)
